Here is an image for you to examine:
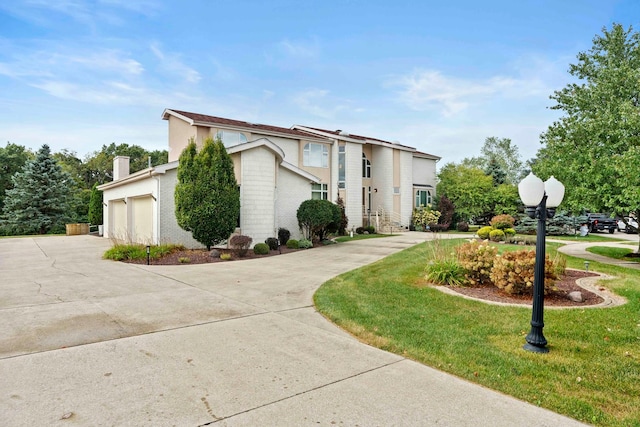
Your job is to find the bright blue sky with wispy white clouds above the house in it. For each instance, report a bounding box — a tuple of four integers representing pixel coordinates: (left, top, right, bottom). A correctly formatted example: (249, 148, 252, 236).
(0, 0, 640, 164)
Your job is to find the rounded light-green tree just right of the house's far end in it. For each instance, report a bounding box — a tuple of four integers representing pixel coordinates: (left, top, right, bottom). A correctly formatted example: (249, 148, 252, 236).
(436, 163, 493, 221)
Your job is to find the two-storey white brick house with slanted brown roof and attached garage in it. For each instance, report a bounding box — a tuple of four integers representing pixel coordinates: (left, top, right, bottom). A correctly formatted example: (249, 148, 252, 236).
(99, 109, 440, 247)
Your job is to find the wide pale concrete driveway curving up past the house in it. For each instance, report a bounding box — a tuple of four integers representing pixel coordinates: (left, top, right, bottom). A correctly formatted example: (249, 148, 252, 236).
(0, 233, 581, 426)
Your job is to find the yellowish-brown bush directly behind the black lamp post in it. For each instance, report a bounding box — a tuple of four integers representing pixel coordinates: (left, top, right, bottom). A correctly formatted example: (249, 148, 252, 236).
(491, 250, 558, 295)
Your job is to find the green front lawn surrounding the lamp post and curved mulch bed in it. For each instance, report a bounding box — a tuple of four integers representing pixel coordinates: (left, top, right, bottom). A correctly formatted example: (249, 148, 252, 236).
(314, 240, 640, 426)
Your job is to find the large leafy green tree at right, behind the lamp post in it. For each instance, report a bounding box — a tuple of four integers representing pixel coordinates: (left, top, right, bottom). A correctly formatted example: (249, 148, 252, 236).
(532, 24, 640, 247)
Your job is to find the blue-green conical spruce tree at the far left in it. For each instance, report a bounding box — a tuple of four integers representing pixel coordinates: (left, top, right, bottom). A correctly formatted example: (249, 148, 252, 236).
(4, 145, 72, 234)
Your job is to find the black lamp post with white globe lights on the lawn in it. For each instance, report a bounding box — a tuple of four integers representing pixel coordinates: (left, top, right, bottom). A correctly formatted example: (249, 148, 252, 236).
(518, 173, 564, 353)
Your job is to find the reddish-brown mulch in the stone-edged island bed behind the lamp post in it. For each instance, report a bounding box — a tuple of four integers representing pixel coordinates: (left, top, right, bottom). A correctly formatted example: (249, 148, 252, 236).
(447, 270, 604, 307)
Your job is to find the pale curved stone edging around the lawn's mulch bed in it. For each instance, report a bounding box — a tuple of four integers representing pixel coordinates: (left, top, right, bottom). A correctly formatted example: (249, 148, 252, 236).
(431, 269, 627, 310)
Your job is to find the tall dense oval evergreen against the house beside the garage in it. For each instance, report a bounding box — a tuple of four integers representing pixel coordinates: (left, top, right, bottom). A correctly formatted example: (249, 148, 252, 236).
(175, 138, 240, 250)
